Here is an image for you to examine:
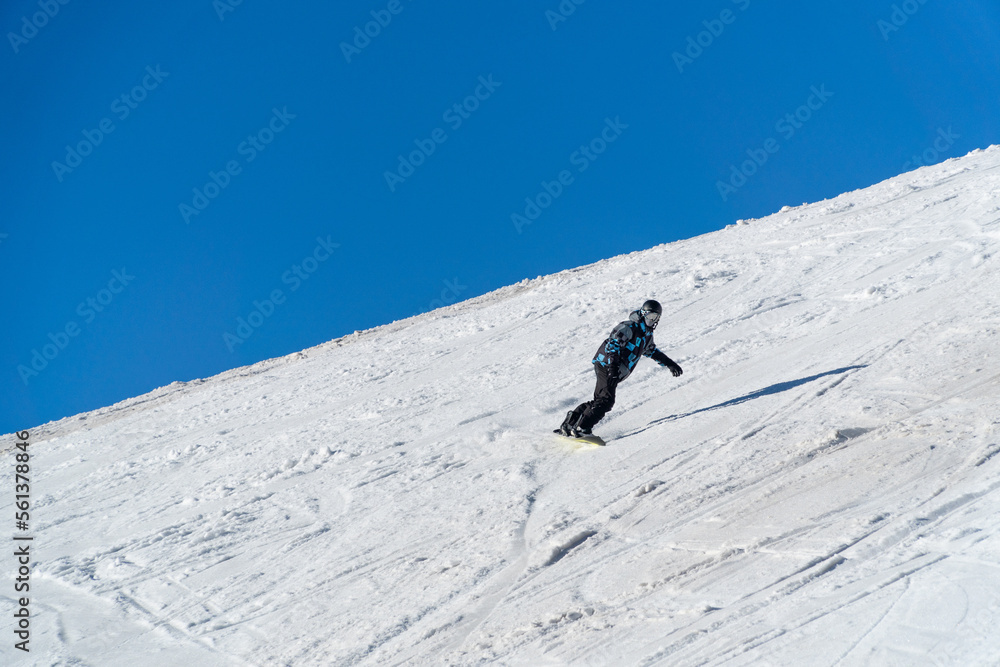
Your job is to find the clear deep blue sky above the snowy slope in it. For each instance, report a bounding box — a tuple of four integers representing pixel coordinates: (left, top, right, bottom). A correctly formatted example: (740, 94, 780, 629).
(0, 0, 1000, 432)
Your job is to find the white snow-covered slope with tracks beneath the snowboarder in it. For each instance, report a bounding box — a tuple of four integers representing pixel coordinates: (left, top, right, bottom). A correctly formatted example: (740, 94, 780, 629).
(0, 147, 1000, 666)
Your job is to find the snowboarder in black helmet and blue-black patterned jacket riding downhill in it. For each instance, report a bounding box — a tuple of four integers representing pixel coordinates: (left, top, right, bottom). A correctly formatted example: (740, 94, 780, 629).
(556, 299, 684, 438)
